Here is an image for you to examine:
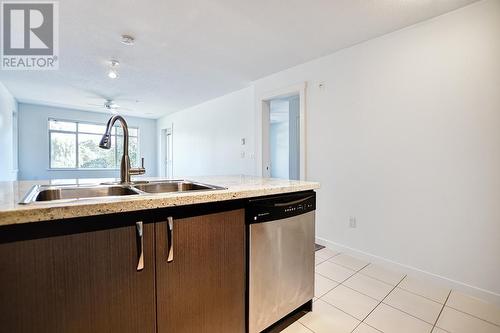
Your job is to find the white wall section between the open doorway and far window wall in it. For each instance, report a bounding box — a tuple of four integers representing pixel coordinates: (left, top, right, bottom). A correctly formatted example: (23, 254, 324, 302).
(158, 87, 255, 177)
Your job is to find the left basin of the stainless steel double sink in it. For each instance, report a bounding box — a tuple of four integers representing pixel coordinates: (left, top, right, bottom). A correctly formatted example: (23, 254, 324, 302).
(21, 185, 139, 203)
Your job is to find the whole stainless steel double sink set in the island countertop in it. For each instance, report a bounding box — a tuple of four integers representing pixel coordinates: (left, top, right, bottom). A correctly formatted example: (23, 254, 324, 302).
(20, 180, 225, 204)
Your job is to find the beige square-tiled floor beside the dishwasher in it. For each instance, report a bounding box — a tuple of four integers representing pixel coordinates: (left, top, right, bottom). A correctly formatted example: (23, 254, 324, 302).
(283, 248, 500, 333)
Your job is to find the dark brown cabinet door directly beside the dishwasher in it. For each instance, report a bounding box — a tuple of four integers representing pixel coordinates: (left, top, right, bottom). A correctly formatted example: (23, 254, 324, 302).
(155, 209, 245, 333)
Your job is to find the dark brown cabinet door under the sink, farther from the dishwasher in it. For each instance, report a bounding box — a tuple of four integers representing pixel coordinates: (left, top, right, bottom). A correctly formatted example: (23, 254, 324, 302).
(0, 222, 156, 333)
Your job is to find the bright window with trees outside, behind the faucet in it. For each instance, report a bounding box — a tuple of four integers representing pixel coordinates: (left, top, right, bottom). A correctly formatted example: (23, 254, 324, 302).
(49, 119, 139, 169)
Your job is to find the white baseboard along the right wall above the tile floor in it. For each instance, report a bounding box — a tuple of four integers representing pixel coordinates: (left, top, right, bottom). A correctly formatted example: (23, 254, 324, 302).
(316, 237, 500, 305)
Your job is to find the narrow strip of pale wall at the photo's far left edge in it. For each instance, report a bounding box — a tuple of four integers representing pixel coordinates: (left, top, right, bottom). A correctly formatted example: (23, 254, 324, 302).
(0, 82, 17, 181)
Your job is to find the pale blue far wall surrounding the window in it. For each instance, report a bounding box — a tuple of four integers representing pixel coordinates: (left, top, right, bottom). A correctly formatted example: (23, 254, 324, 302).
(19, 103, 157, 179)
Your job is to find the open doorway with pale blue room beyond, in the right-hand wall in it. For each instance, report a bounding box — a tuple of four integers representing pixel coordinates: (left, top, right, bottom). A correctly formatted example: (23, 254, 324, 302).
(268, 95, 300, 180)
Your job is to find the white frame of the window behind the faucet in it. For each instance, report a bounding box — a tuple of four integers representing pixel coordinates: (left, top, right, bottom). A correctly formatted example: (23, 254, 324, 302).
(47, 118, 141, 171)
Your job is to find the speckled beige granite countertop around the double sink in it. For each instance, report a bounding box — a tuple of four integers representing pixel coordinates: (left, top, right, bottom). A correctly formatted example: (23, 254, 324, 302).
(0, 176, 319, 226)
